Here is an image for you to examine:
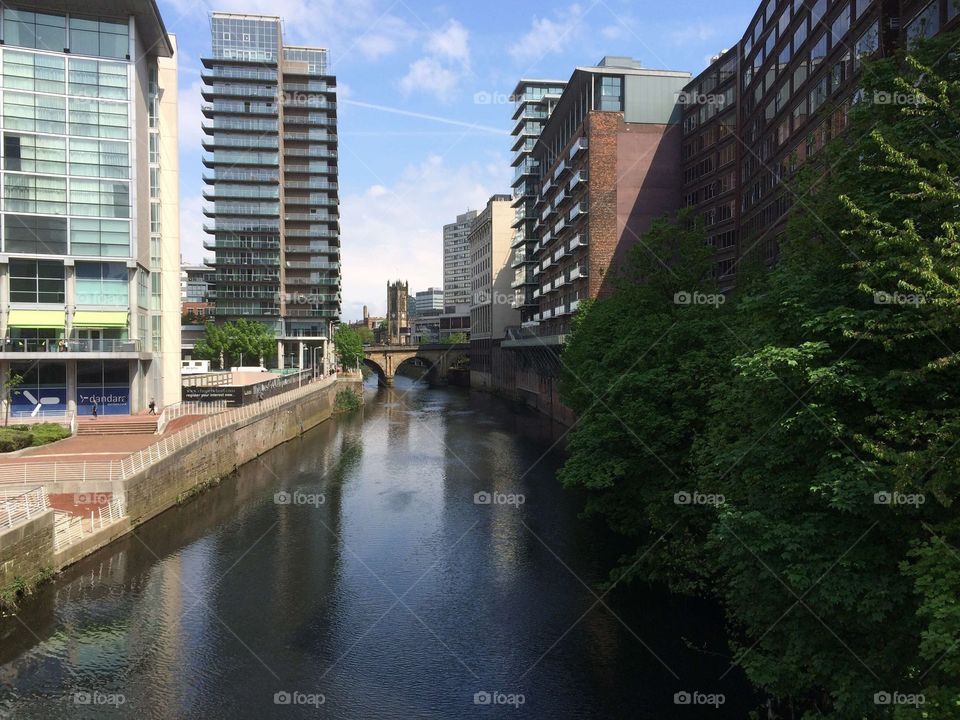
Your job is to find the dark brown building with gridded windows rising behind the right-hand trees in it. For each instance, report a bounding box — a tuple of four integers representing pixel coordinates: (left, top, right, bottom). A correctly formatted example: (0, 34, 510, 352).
(682, 0, 960, 287)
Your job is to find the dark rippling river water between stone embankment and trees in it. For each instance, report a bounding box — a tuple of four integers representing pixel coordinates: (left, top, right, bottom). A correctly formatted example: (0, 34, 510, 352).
(0, 378, 753, 720)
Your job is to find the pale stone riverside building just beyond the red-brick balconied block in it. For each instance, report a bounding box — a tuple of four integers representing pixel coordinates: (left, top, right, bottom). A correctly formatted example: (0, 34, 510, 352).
(470, 195, 520, 388)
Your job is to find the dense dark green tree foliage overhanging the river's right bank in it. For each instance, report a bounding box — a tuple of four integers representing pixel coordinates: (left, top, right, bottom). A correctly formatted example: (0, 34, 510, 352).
(562, 33, 960, 719)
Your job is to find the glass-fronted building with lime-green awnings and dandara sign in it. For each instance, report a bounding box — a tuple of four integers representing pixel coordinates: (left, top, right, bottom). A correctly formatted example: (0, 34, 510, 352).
(0, 0, 180, 414)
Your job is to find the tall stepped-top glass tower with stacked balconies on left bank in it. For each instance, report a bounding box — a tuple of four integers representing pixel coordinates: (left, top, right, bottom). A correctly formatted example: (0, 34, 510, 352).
(203, 12, 341, 367)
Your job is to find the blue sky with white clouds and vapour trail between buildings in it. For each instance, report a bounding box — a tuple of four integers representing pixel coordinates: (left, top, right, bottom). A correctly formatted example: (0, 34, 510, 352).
(159, 0, 758, 321)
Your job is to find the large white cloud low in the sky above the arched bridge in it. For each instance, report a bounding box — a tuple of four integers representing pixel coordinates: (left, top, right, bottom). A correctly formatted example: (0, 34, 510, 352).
(340, 155, 510, 320)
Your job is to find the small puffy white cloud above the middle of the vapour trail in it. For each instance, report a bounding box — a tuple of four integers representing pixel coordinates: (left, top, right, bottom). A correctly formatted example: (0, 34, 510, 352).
(400, 20, 470, 101)
